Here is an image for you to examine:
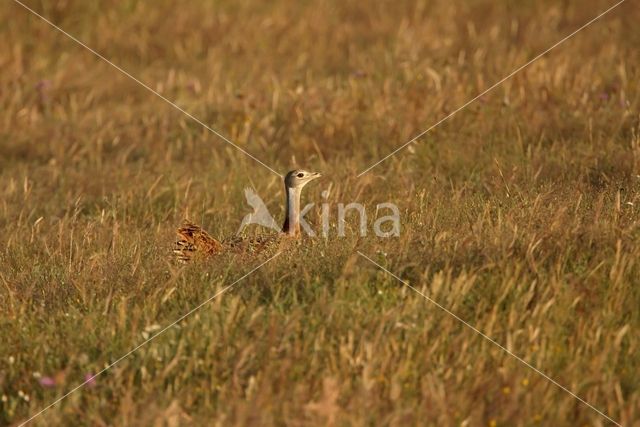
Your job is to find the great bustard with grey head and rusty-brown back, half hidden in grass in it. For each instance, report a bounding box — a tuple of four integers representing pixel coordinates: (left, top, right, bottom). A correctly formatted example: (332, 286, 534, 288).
(173, 169, 322, 262)
